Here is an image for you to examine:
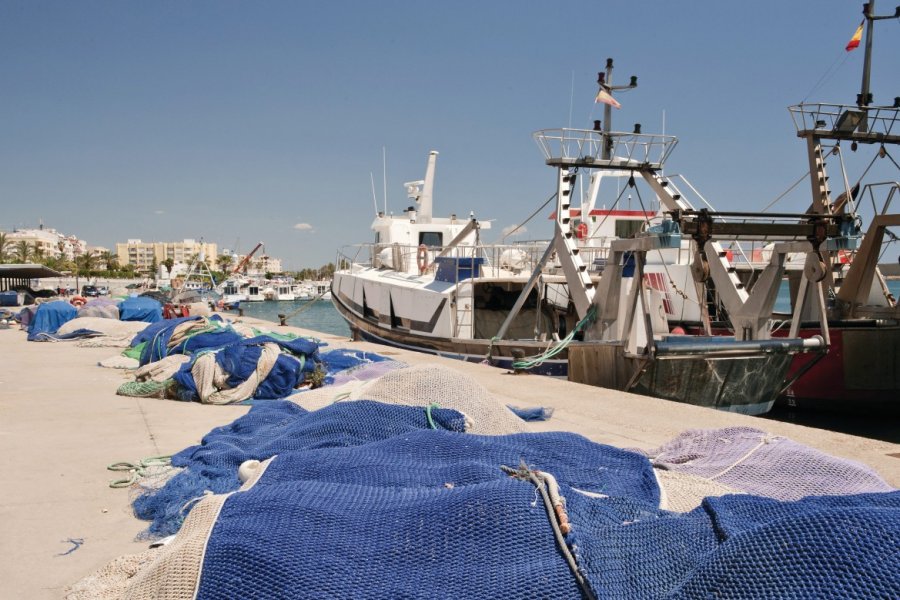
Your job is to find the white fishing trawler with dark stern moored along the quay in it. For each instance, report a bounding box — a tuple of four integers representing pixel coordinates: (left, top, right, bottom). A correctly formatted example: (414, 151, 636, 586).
(333, 54, 880, 414)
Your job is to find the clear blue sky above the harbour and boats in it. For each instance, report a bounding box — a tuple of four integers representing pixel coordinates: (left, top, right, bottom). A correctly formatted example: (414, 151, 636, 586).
(0, 0, 900, 269)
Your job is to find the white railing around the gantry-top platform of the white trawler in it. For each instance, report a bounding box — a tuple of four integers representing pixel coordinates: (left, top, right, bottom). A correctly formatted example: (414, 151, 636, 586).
(532, 128, 678, 169)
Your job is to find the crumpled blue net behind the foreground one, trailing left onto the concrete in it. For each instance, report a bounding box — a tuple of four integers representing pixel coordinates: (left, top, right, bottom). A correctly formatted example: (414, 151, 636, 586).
(133, 401, 465, 537)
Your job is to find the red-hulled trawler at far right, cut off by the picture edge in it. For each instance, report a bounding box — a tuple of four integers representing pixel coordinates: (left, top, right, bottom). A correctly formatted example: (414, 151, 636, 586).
(732, 2, 900, 415)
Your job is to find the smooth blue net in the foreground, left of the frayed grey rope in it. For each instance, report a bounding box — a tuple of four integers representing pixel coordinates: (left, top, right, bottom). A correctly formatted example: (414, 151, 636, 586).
(198, 426, 659, 598)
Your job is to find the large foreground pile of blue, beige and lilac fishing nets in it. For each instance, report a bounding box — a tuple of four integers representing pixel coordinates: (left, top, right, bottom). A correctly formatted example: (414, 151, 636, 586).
(70, 369, 900, 599)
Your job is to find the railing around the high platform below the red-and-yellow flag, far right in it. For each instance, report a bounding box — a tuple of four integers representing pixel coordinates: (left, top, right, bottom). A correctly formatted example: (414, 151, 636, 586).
(788, 104, 900, 143)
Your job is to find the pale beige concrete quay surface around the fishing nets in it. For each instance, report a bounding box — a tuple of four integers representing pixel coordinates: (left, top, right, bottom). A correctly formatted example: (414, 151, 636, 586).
(0, 317, 900, 599)
